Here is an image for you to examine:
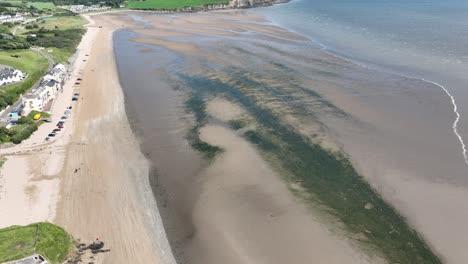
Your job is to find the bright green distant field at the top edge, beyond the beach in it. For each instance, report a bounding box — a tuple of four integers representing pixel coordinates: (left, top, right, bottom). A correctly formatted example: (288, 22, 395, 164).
(127, 0, 229, 9)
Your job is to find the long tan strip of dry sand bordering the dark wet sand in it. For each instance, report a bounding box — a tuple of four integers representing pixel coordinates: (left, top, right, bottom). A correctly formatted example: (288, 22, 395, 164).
(56, 16, 173, 263)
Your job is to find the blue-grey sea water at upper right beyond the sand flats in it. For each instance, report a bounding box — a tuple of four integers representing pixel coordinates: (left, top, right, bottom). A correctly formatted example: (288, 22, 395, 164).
(255, 0, 468, 163)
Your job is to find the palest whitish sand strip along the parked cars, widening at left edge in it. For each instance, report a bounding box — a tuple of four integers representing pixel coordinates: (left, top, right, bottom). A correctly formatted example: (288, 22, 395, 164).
(0, 18, 96, 227)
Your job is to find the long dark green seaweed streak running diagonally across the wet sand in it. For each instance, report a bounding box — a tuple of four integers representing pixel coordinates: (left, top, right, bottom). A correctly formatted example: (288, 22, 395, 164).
(179, 75, 441, 264)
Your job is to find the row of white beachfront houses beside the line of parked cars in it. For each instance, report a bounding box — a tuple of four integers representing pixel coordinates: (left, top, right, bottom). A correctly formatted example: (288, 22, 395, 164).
(21, 64, 66, 116)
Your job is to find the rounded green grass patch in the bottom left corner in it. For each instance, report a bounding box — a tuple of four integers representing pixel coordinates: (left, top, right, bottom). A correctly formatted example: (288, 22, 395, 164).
(0, 223, 73, 263)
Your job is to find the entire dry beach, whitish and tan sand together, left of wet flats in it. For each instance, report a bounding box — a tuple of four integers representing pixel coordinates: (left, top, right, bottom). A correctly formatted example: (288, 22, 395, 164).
(0, 13, 173, 263)
